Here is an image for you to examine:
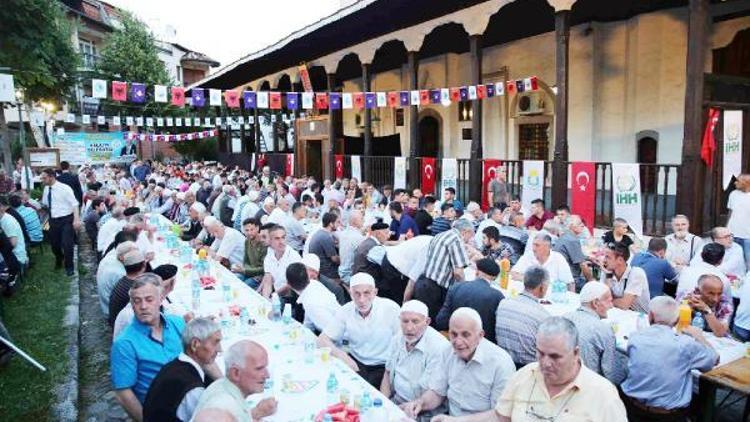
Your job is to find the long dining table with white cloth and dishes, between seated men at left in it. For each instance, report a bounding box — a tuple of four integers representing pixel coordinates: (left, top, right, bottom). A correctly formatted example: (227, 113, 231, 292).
(149, 216, 411, 422)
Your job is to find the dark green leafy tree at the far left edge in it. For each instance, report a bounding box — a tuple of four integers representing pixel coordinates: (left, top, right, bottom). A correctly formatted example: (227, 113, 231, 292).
(0, 0, 79, 170)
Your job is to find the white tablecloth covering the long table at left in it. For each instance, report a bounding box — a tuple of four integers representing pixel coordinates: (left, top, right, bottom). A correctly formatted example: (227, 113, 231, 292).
(152, 216, 408, 422)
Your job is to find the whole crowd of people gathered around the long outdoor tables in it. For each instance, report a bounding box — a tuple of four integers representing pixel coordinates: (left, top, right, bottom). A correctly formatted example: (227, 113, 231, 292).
(11, 156, 750, 421)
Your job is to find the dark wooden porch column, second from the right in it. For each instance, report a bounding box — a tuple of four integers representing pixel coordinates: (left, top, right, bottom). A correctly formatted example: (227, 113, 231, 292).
(547, 10, 570, 209)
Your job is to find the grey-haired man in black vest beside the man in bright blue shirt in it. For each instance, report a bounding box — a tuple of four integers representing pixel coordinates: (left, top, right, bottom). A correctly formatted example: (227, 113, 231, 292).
(143, 318, 222, 422)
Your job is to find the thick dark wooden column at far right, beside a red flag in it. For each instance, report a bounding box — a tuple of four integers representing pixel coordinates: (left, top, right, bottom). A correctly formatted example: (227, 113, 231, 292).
(676, 0, 708, 233)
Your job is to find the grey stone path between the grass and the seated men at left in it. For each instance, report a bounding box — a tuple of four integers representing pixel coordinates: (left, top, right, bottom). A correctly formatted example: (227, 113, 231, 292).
(78, 235, 129, 422)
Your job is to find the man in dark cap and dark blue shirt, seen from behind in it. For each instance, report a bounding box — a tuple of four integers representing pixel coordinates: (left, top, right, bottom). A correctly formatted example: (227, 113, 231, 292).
(435, 258, 504, 343)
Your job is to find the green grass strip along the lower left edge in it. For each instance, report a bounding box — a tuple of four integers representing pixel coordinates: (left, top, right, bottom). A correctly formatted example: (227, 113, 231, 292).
(0, 249, 71, 421)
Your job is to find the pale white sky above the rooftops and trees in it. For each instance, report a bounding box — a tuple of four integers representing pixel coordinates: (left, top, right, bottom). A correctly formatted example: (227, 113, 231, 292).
(106, 0, 341, 71)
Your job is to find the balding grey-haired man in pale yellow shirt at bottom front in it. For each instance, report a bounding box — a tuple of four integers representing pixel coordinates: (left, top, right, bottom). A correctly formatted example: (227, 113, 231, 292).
(468, 317, 628, 422)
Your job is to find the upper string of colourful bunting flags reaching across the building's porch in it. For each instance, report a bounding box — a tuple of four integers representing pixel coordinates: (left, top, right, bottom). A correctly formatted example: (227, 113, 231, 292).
(86, 76, 539, 110)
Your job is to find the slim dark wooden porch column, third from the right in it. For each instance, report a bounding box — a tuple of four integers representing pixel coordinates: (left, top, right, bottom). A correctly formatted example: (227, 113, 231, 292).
(469, 35, 483, 202)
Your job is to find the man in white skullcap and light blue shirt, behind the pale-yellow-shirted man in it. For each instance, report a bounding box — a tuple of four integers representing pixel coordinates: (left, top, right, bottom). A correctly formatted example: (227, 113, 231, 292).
(565, 281, 627, 385)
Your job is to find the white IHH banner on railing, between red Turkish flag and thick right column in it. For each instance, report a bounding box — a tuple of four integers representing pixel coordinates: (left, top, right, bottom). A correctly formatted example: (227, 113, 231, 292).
(612, 163, 643, 237)
